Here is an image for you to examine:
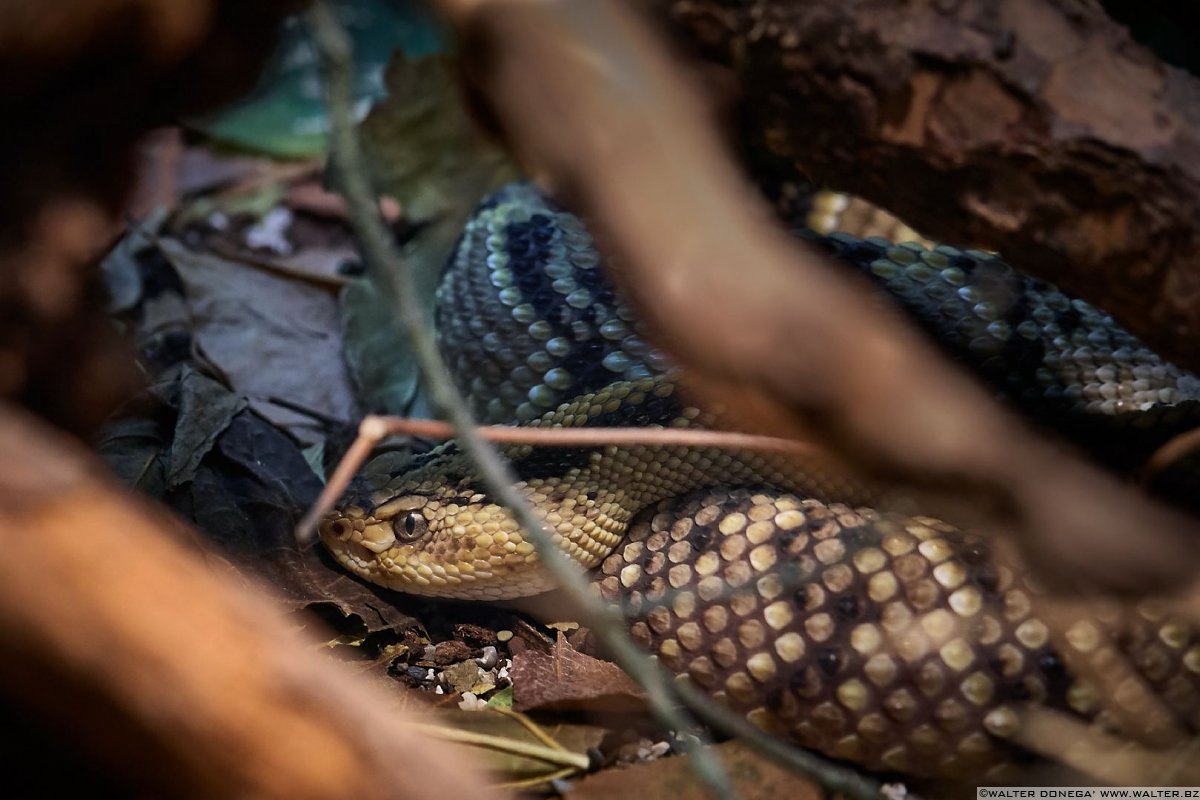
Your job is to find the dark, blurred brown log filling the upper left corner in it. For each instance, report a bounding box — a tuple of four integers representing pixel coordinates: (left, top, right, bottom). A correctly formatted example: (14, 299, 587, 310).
(0, 0, 302, 437)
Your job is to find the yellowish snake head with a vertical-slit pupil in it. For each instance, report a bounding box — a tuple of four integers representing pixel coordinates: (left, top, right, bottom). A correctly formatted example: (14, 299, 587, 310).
(318, 472, 552, 600)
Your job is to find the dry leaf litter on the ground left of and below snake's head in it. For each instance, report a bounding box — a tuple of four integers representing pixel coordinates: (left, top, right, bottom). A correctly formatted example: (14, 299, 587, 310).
(97, 20, 835, 798)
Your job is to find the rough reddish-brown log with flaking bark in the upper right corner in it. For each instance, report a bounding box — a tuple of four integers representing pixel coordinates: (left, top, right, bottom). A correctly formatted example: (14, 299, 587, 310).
(652, 0, 1200, 369)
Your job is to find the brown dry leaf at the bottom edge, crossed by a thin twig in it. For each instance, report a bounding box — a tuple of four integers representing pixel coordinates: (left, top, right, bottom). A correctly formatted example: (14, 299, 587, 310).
(571, 741, 824, 800)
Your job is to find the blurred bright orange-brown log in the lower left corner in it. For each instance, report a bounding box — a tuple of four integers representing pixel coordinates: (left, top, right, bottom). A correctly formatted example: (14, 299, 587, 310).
(0, 407, 494, 799)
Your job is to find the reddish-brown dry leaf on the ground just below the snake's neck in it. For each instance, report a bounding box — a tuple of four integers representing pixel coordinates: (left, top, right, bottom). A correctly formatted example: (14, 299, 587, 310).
(510, 633, 646, 711)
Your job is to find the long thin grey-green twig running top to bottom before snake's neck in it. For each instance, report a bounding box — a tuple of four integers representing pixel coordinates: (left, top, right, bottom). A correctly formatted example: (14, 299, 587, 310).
(307, 2, 748, 798)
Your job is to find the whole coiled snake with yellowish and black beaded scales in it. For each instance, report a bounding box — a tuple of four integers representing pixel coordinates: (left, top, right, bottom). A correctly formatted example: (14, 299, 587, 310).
(320, 184, 1200, 780)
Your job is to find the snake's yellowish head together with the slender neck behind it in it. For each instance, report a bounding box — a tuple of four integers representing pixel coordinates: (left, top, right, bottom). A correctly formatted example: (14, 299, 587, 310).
(320, 377, 863, 600)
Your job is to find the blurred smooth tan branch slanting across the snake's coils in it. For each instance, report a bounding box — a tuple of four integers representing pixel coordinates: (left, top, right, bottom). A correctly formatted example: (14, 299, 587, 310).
(440, 0, 1200, 599)
